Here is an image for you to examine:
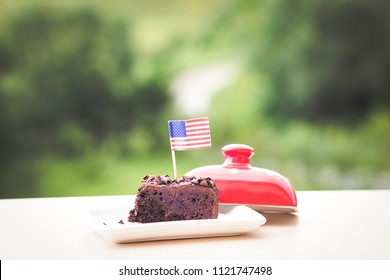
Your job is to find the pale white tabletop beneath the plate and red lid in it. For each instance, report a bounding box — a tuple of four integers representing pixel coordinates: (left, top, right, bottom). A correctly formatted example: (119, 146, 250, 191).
(0, 190, 390, 260)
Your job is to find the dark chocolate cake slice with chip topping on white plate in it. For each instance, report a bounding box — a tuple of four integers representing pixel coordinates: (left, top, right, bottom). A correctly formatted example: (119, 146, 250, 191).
(128, 175, 218, 223)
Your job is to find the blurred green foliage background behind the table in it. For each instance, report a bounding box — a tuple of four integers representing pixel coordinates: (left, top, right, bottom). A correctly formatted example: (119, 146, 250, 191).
(0, 0, 390, 198)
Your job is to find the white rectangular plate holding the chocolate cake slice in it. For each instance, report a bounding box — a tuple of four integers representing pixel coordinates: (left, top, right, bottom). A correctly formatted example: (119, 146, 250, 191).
(87, 205, 266, 243)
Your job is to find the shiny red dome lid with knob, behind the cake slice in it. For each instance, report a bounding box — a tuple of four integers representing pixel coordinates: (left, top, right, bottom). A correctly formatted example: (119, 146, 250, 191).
(185, 144, 297, 212)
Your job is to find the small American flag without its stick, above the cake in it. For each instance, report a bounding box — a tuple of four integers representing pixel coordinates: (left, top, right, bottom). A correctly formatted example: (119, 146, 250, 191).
(168, 117, 211, 151)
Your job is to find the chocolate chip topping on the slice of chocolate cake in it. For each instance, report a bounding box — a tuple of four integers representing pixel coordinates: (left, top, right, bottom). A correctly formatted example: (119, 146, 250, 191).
(142, 175, 215, 188)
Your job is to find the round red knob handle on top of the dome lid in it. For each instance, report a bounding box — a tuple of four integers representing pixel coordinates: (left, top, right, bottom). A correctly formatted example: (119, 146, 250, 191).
(221, 144, 255, 168)
